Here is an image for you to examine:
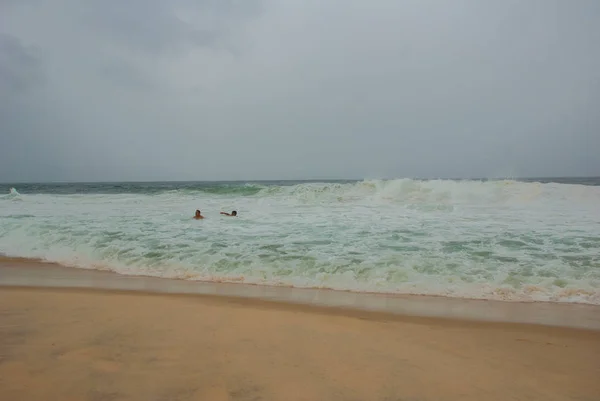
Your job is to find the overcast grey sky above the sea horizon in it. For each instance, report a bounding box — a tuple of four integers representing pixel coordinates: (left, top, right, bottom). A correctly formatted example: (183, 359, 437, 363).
(0, 0, 600, 182)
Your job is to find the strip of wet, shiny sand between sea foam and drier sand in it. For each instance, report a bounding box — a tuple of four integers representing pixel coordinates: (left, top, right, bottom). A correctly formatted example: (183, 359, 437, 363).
(0, 257, 600, 331)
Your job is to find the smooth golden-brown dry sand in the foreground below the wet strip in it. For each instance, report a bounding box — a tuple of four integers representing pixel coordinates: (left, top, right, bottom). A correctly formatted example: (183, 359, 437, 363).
(0, 264, 600, 401)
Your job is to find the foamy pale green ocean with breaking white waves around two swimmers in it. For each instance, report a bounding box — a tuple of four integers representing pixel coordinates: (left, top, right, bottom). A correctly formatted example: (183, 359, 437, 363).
(0, 178, 600, 304)
